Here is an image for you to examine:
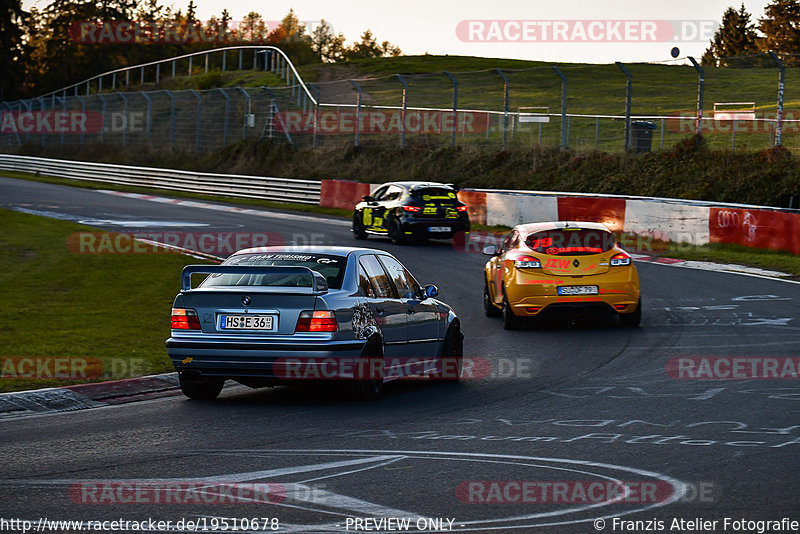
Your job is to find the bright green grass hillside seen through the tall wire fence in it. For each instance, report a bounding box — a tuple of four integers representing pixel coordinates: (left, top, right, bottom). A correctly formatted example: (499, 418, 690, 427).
(79, 55, 800, 151)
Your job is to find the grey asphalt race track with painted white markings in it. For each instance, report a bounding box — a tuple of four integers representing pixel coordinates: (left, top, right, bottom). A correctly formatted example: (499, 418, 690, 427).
(0, 178, 800, 533)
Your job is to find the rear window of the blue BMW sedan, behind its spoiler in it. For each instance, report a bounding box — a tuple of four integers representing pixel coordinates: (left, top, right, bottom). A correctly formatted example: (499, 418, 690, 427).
(200, 252, 347, 289)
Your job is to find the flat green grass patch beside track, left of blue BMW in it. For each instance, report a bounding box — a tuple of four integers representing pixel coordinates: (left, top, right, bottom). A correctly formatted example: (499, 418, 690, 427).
(0, 210, 212, 391)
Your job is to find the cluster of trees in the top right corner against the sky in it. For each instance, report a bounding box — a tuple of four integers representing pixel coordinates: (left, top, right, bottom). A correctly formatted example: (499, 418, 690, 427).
(702, 0, 800, 67)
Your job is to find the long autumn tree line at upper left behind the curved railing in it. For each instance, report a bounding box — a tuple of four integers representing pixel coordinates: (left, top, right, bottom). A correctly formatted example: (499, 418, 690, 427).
(0, 0, 401, 102)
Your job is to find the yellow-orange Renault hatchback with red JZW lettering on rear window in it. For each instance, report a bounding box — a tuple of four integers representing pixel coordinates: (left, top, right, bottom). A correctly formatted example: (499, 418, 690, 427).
(483, 221, 642, 330)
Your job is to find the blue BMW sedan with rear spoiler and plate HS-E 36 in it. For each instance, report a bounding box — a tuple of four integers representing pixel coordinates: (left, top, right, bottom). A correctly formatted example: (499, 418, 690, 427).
(167, 247, 463, 400)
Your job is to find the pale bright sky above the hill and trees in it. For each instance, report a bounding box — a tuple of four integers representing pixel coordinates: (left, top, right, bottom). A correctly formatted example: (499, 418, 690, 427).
(24, 0, 768, 63)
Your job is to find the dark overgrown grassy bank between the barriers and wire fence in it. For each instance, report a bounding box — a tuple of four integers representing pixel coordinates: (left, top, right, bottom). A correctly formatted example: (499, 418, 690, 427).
(14, 138, 800, 206)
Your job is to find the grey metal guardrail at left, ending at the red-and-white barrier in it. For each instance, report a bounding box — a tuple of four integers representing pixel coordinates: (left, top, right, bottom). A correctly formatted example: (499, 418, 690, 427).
(0, 154, 321, 204)
